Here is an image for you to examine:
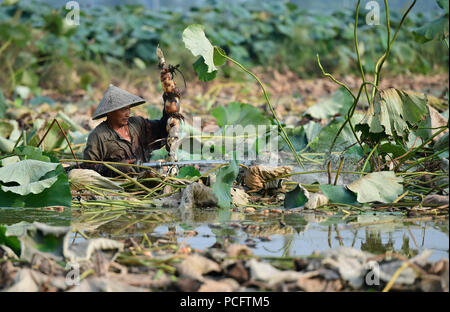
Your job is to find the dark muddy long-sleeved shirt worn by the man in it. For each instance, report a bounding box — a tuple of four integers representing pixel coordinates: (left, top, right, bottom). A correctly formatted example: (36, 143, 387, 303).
(82, 116, 167, 177)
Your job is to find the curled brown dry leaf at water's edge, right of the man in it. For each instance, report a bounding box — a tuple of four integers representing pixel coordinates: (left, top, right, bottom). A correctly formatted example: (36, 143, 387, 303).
(244, 165, 292, 191)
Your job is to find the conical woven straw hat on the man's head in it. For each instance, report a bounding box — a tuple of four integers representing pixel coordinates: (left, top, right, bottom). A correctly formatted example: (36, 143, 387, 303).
(92, 84, 145, 120)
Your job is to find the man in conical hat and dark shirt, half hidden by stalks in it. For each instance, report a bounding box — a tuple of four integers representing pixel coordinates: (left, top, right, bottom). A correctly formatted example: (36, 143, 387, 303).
(82, 85, 175, 177)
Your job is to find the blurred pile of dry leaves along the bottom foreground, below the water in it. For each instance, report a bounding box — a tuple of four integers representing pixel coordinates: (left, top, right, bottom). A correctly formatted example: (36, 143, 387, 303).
(0, 229, 449, 292)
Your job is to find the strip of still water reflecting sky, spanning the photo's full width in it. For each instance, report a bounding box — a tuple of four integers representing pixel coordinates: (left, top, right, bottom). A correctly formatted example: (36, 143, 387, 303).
(0, 208, 449, 261)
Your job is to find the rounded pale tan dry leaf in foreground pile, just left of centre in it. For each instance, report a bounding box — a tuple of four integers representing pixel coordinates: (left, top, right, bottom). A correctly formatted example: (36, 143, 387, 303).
(177, 254, 220, 282)
